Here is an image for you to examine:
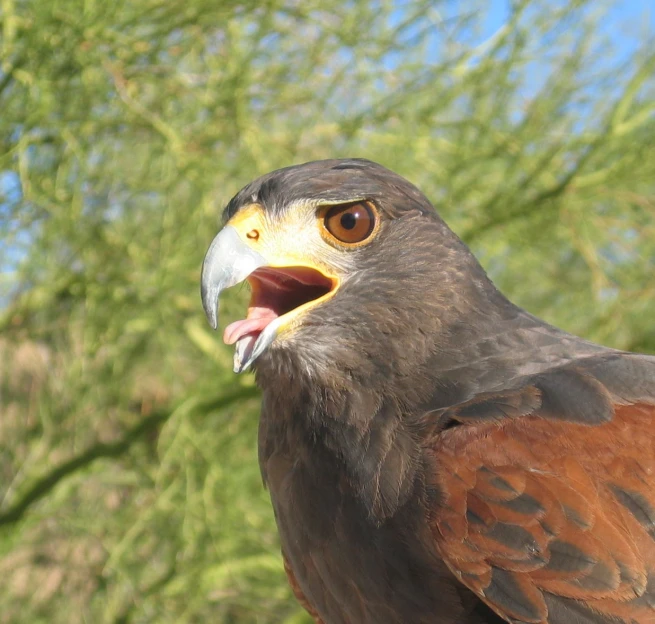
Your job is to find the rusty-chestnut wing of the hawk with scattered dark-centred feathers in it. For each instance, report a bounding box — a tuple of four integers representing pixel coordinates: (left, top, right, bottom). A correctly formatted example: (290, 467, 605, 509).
(431, 390, 655, 624)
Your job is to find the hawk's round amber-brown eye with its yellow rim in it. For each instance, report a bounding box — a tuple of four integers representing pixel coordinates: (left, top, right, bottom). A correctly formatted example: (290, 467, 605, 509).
(319, 201, 380, 247)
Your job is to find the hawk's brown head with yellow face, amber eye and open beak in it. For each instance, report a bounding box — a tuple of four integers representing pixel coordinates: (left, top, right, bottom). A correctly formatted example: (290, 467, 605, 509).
(201, 159, 502, 394)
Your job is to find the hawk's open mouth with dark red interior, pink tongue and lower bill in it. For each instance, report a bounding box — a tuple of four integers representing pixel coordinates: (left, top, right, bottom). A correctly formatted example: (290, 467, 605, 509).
(223, 267, 337, 369)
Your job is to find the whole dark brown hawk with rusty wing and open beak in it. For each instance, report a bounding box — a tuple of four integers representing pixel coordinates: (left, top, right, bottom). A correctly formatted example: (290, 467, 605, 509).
(202, 159, 655, 624)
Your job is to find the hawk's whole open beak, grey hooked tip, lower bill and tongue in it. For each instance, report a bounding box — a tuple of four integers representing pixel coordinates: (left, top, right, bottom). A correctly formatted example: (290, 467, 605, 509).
(200, 222, 338, 373)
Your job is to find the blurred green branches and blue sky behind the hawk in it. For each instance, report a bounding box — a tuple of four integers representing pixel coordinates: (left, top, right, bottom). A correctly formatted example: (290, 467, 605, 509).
(0, 0, 655, 624)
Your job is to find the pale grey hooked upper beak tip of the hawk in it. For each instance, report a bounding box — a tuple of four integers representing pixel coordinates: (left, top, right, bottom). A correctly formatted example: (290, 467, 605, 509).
(200, 225, 268, 329)
